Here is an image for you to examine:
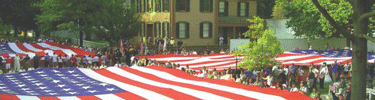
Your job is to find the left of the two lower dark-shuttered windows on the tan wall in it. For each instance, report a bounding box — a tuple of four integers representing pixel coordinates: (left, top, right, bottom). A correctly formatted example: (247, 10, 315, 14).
(176, 23, 189, 39)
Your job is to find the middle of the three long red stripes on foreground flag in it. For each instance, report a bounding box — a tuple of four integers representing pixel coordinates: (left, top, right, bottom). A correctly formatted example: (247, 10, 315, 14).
(121, 67, 252, 100)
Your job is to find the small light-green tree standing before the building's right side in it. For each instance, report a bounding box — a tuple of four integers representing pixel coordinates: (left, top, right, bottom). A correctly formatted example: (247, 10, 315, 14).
(234, 17, 284, 69)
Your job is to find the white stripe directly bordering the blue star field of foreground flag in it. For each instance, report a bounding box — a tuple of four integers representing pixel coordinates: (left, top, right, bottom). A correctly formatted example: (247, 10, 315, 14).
(79, 68, 172, 100)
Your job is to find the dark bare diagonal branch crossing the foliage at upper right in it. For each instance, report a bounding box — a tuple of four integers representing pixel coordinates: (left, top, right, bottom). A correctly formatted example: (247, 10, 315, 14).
(312, 0, 354, 40)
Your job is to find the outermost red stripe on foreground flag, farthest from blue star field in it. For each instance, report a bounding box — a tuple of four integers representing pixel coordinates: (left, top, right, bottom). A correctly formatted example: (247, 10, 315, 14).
(147, 66, 314, 100)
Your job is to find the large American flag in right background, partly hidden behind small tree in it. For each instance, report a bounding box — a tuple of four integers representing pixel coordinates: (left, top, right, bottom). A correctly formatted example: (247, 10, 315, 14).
(143, 50, 375, 71)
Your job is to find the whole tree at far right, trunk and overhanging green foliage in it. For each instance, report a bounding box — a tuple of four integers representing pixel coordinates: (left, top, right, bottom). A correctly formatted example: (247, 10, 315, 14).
(286, 0, 375, 100)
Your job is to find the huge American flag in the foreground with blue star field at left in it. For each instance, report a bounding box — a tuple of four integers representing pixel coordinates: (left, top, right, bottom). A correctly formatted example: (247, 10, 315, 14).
(0, 66, 311, 100)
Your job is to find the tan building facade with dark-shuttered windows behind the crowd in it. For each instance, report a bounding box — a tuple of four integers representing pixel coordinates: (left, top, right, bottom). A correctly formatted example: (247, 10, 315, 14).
(131, 0, 257, 46)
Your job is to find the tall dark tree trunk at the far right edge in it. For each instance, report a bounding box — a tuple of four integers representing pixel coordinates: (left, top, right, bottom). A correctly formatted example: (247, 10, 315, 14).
(350, 0, 371, 100)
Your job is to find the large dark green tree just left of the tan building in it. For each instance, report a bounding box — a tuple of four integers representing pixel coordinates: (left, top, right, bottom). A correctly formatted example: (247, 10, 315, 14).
(36, 0, 138, 46)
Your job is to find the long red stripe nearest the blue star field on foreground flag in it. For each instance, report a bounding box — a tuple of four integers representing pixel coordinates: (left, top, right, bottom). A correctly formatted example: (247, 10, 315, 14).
(95, 69, 199, 100)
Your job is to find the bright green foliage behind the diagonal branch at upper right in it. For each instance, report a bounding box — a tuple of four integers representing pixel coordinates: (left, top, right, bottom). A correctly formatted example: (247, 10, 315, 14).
(276, 0, 375, 39)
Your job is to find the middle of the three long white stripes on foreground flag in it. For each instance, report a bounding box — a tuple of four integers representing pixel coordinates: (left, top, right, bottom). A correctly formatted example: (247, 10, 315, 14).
(107, 67, 229, 100)
